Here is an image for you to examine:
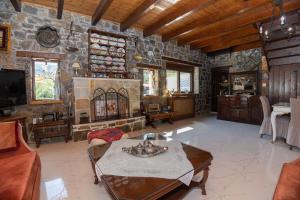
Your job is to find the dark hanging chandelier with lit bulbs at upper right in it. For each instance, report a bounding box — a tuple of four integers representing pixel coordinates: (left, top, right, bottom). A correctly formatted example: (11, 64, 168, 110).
(259, 0, 296, 41)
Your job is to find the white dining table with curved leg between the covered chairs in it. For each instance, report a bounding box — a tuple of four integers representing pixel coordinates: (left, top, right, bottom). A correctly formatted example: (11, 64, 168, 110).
(271, 102, 291, 143)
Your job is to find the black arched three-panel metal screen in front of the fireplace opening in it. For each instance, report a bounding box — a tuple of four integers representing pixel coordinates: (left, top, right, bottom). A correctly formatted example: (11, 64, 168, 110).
(92, 88, 129, 121)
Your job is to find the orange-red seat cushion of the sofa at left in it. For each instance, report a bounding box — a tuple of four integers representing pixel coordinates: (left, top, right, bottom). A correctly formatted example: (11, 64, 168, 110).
(0, 152, 40, 200)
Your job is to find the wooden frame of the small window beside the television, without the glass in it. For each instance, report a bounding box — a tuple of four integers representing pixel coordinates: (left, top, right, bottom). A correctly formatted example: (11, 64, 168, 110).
(30, 58, 63, 105)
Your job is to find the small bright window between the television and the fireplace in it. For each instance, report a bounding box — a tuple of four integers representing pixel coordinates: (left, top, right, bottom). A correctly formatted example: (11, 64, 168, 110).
(32, 60, 60, 101)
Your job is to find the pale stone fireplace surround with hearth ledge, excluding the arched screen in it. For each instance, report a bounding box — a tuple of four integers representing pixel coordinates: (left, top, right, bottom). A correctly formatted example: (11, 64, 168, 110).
(73, 77, 145, 141)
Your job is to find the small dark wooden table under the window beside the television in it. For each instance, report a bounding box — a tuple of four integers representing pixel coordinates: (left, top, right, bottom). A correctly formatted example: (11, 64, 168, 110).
(32, 120, 70, 148)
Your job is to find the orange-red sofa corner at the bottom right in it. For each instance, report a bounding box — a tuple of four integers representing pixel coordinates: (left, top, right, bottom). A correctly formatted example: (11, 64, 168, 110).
(273, 158, 300, 200)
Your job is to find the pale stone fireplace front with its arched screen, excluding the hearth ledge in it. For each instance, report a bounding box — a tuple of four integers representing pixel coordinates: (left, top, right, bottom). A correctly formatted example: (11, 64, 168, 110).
(73, 77, 140, 124)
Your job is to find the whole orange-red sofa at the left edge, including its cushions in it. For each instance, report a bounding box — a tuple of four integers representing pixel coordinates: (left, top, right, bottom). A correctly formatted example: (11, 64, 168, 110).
(0, 122, 41, 200)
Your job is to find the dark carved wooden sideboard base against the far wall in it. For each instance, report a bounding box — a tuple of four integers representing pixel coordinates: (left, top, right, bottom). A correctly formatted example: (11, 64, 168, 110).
(217, 95, 263, 125)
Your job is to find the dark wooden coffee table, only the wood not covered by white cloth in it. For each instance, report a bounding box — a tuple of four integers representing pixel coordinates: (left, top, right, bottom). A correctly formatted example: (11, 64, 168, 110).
(88, 135, 213, 200)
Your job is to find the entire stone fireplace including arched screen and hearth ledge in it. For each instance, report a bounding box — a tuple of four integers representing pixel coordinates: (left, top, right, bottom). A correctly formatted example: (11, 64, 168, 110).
(72, 77, 146, 141)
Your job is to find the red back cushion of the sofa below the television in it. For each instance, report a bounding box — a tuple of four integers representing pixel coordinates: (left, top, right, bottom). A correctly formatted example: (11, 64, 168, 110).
(0, 121, 19, 152)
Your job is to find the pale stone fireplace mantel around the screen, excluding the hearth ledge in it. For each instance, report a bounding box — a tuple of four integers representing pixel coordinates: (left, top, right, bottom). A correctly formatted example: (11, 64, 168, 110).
(73, 77, 141, 124)
